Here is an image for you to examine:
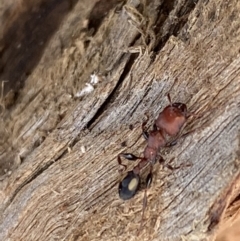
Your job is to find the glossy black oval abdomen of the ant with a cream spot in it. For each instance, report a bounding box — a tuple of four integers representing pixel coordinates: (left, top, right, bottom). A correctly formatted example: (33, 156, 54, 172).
(118, 171, 140, 200)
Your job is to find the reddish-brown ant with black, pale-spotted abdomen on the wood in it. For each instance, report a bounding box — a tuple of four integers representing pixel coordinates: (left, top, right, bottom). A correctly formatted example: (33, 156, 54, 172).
(118, 94, 189, 230)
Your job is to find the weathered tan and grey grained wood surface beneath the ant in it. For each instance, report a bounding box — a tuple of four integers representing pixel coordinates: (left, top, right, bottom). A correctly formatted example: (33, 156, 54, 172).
(0, 0, 240, 241)
